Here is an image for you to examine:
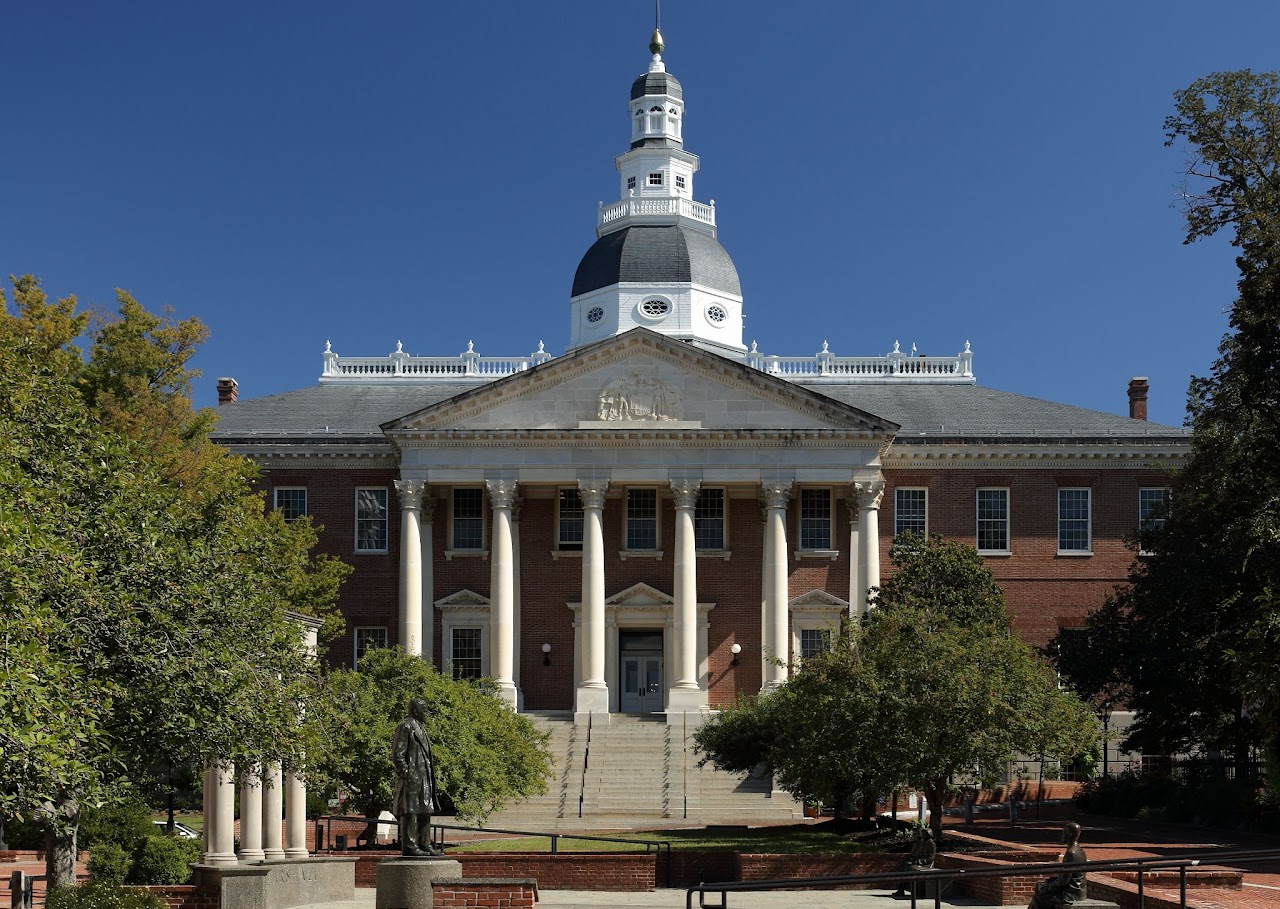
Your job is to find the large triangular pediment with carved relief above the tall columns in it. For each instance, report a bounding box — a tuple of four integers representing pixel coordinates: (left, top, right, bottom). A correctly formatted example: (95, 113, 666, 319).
(383, 329, 897, 438)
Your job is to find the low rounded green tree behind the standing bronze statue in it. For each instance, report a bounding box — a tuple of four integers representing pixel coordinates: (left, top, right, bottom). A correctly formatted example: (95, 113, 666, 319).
(308, 649, 550, 819)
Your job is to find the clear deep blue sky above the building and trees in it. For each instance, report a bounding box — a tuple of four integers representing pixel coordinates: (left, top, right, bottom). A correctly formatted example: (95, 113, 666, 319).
(0, 0, 1280, 424)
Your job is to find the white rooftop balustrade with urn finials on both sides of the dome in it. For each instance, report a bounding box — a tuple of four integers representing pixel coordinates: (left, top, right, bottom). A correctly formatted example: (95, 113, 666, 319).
(320, 342, 975, 384)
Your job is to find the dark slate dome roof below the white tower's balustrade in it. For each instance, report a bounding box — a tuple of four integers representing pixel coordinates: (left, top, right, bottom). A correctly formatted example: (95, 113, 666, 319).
(570, 224, 742, 297)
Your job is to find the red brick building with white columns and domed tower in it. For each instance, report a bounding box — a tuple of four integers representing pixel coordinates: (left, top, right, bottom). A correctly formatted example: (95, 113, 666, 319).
(215, 24, 1188, 732)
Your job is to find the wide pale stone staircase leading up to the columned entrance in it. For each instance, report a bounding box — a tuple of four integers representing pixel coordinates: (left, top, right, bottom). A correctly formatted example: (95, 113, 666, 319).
(486, 713, 803, 830)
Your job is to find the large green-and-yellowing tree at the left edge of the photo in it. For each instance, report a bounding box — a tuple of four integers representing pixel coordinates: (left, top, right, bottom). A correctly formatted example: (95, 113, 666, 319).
(0, 277, 344, 886)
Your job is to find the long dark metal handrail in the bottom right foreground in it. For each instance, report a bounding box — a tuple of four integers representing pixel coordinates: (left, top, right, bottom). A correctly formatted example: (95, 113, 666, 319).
(685, 849, 1280, 909)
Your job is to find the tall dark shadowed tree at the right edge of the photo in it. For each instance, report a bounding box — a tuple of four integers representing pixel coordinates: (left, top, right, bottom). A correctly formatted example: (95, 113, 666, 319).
(1060, 70, 1280, 768)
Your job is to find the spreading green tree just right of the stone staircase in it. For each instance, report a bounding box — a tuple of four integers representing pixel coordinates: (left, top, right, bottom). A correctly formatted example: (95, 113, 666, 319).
(695, 535, 1097, 837)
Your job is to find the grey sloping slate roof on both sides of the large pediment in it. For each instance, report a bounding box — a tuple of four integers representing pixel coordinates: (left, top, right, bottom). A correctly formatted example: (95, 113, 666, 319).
(214, 373, 1189, 446)
